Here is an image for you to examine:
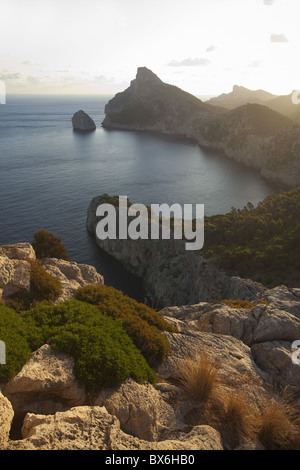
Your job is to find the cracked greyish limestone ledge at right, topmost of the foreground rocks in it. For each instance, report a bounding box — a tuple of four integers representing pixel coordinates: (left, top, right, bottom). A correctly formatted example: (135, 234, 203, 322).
(161, 286, 300, 346)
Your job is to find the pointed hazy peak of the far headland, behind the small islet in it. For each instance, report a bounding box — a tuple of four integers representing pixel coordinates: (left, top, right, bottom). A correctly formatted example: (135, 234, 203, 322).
(102, 67, 223, 136)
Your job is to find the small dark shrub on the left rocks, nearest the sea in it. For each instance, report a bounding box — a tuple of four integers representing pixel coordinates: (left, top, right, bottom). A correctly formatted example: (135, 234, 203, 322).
(32, 228, 70, 261)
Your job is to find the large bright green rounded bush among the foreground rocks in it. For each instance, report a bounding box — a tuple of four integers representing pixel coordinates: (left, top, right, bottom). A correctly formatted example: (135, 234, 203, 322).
(23, 299, 155, 392)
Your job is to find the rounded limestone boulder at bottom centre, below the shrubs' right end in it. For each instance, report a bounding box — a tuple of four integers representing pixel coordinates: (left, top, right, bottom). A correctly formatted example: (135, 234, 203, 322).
(103, 380, 176, 441)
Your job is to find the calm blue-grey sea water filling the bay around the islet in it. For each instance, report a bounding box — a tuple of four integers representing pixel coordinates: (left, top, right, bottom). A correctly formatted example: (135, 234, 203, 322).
(0, 96, 275, 296)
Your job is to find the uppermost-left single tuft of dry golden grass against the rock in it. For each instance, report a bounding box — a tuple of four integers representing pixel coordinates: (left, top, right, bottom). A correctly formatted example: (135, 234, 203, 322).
(178, 353, 220, 401)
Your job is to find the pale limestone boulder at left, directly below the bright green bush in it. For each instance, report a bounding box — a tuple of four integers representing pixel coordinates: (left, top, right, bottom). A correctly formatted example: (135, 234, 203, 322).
(3, 344, 86, 413)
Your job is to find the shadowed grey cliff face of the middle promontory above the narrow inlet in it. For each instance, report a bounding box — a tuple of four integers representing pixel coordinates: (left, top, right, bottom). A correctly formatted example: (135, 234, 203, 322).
(86, 196, 263, 307)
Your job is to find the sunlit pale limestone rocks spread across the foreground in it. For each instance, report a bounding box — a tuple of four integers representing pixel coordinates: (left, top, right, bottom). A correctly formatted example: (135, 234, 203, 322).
(0, 244, 300, 450)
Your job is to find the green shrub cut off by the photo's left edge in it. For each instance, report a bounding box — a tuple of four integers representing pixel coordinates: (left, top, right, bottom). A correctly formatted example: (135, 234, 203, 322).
(0, 304, 31, 383)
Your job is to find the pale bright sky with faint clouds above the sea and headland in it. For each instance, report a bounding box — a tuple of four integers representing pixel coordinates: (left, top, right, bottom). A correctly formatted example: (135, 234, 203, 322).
(0, 0, 300, 97)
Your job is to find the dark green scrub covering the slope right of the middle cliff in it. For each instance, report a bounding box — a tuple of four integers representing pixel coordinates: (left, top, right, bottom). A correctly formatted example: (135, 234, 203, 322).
(203, 188, 300, 287)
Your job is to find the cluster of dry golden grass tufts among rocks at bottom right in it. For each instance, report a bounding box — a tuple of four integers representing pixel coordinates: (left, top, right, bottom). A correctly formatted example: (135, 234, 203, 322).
(177, 351, 300, 450)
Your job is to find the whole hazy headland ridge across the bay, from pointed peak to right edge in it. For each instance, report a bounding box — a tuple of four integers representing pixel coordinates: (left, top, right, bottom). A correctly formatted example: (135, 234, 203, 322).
(102, 67, 300, 187)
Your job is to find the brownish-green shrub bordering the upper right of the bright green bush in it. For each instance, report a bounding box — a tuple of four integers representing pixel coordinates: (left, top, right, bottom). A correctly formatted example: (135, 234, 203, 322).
(75, 285, 176, 367)
